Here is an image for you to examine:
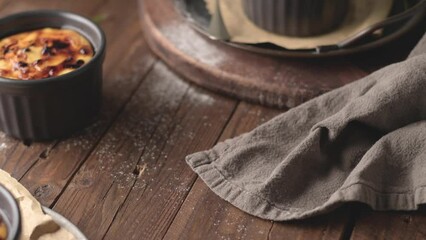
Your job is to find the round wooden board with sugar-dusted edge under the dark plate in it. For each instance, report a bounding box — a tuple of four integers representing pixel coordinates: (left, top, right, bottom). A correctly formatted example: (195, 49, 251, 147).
(139, 0, 365, 108)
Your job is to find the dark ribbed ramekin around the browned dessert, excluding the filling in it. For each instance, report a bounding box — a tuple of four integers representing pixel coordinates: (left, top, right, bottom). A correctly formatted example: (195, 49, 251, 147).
(0, 10, 106, 140)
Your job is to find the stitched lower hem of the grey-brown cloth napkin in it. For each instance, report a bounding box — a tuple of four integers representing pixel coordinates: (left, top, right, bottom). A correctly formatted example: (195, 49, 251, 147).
(186, 151, 426, 221)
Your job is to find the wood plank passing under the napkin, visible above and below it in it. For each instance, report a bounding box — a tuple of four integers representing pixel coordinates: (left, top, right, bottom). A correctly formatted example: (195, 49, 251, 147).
(165, 103, 279, 239)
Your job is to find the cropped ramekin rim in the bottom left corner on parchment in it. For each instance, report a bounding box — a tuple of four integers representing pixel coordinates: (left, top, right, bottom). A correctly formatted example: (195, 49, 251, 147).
(0, 185, 21, 240)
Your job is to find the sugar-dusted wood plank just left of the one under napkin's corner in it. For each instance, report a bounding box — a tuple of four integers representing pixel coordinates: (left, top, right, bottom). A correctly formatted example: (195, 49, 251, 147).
(54, 62, 193, 239)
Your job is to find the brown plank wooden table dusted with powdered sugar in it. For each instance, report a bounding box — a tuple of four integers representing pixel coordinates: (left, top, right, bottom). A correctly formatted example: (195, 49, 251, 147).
(0, 0, 426, 239)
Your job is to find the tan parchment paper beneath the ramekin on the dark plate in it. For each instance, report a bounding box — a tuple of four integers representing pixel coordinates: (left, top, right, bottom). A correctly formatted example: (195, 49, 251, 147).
(205, 0, 392, 49)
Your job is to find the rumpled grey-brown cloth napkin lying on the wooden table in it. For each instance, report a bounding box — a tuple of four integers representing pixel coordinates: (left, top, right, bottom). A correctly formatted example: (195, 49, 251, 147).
(186, 32, 426, 221)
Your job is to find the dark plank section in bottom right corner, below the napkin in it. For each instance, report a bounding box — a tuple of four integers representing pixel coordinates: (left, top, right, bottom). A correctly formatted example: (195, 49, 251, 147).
(351, 207, 426, 240)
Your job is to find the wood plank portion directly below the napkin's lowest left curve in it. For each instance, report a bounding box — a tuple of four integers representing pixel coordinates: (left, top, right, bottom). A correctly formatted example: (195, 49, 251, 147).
(164, 179, 272, 240)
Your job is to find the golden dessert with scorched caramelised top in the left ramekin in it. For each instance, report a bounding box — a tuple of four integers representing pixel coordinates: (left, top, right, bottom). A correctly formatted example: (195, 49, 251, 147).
(0, 28, 94, 80)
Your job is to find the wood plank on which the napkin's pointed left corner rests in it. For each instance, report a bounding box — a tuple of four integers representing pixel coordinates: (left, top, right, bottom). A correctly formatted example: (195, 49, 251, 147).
(102, 83, 235, 239)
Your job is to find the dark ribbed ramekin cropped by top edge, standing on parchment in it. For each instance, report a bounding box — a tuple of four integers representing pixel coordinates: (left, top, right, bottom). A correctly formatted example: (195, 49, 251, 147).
(243, 0, 349, 37)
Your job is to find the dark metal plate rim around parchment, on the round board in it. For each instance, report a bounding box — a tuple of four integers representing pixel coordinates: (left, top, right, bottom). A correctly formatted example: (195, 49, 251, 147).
(176, 0, 425, 58)
